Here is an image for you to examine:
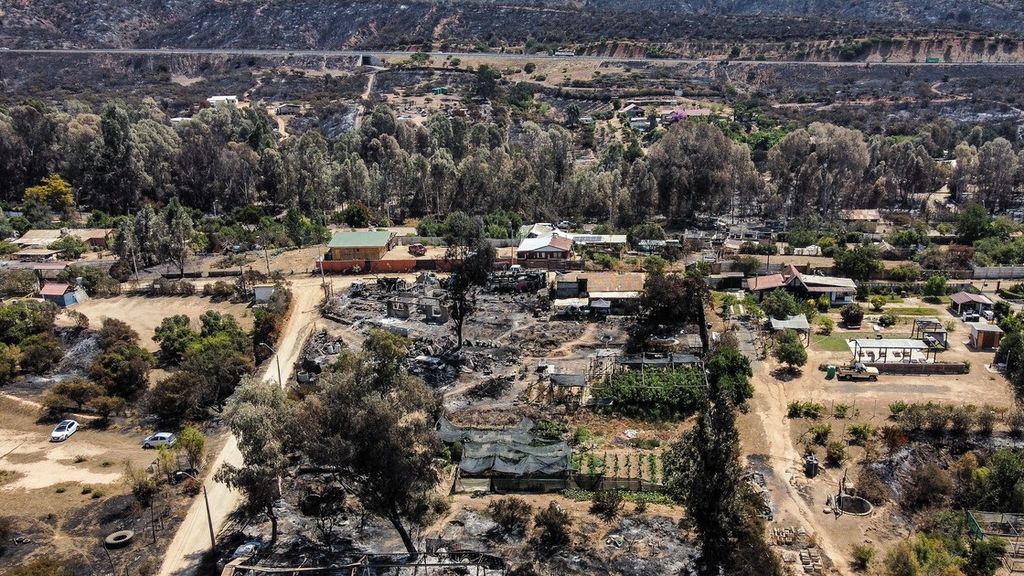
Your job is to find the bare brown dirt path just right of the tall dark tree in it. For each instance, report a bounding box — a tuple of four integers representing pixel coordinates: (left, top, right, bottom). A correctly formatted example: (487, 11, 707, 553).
(751, 362, 852, 574)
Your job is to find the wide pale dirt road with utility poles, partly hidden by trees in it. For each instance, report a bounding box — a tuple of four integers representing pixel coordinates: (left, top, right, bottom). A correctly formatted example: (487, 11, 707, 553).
(159, 277, 329, 576)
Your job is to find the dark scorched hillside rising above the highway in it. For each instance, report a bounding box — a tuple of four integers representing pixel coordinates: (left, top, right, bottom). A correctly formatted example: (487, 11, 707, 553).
(0, 0, 1024, 49)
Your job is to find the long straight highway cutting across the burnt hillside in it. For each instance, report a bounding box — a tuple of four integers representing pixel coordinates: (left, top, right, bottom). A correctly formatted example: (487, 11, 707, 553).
(6, 48, 1024, 68)
